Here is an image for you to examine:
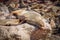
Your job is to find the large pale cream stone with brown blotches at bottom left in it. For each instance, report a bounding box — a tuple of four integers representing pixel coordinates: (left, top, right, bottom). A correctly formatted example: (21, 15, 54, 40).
(0, 23, 35, 40)
